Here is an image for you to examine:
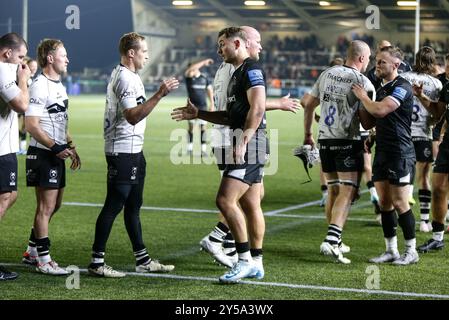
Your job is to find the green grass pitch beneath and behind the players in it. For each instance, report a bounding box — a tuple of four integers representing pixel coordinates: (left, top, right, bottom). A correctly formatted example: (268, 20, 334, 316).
(0, 96, 449, 300)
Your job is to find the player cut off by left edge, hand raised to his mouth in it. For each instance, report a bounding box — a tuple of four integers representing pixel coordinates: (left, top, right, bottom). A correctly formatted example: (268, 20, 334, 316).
(0, 33, 30, 281)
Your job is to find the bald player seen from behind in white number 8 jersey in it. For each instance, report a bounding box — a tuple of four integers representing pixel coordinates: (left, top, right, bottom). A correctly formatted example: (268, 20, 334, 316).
(303, 40, 374, 264)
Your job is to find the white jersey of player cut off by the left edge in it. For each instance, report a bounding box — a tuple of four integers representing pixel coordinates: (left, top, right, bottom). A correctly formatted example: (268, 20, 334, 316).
(0, 62, 20, 156)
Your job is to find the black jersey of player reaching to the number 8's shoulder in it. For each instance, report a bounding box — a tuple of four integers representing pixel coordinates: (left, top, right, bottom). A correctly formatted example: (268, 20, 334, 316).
(376, 76, 415, 158)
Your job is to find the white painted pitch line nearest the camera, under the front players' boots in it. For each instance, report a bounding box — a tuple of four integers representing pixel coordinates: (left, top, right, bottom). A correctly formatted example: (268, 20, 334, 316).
(2, 263, 449, 299)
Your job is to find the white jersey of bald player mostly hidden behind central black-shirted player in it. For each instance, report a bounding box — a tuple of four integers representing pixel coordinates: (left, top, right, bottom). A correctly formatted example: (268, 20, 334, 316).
(210, 62, 235, 148)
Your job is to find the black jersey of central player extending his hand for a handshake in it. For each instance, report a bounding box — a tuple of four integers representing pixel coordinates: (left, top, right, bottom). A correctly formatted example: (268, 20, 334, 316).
(226, 58, 266, 129)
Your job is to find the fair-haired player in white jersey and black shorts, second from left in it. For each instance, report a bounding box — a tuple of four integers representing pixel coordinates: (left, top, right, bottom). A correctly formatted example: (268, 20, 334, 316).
(22, 39, 81, 275)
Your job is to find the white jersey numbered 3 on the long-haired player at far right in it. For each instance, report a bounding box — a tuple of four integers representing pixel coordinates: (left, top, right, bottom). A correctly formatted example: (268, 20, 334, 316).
(401, 71, 443, 139)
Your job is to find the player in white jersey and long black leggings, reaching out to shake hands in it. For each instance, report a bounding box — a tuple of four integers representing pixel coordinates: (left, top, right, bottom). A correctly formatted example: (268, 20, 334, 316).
(89, 32, 179, 278)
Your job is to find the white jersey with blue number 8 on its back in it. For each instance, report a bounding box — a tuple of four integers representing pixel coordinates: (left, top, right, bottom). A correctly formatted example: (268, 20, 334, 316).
(310, 66, 375, 140)
